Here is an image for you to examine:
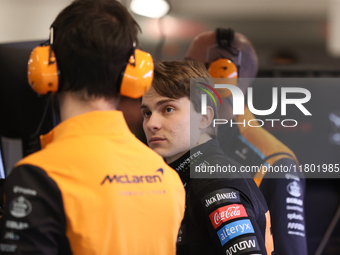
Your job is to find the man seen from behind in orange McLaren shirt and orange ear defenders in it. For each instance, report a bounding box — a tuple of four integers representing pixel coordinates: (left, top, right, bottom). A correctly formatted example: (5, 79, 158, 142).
(0, 0, 185, 255)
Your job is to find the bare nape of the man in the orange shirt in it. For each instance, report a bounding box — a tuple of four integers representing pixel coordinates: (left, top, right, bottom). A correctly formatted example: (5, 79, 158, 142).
(60, 92, 119, 121)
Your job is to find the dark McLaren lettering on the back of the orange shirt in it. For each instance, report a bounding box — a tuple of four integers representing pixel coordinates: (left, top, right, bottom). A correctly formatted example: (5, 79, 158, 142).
(101, 168, 164, 185)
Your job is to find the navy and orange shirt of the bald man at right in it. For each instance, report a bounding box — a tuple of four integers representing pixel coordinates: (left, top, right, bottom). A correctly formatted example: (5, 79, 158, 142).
(218, 107, 307, 255)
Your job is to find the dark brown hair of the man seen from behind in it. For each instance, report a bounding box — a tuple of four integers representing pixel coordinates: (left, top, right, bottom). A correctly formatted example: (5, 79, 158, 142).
(52, 0, 140, 99)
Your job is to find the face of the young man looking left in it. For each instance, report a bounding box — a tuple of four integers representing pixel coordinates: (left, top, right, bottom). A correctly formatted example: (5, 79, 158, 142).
(141, 87, 200, 163)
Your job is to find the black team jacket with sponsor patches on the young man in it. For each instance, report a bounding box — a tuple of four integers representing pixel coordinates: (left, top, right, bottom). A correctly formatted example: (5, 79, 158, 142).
(170, 139, 273, 255)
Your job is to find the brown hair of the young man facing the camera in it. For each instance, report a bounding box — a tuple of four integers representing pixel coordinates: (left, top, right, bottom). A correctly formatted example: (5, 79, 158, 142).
(152, 60, 218, 137)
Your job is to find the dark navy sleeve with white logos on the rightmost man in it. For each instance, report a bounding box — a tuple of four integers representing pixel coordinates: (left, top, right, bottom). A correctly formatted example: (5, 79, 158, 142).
(260, 158, 307, 255)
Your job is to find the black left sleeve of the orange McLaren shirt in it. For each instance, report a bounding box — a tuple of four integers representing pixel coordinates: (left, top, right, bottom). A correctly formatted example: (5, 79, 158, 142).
(0, 165, 71, 255)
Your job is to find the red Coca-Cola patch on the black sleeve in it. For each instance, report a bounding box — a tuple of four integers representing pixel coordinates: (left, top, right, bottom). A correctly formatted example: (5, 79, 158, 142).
(209, 204, 248, 228)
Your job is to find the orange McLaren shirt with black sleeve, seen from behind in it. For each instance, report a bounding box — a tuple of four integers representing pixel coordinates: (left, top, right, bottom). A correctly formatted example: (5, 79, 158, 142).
(0, 111, 185, 255)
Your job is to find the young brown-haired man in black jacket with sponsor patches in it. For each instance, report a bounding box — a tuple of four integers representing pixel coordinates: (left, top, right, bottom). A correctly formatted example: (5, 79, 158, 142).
(141, 61, 273, 255)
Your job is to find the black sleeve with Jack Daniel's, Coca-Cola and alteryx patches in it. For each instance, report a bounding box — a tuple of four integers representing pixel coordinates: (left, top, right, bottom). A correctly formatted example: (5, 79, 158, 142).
(191, 179, 267, 255)
